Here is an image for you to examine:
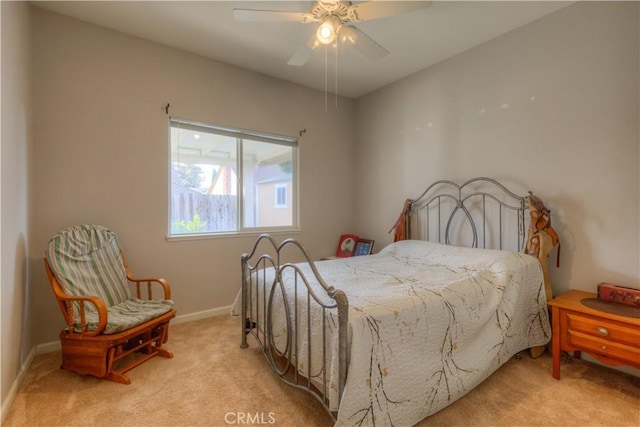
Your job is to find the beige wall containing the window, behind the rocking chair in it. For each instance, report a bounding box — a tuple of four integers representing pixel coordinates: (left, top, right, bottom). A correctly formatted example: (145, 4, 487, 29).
(31, 8, 355, 343)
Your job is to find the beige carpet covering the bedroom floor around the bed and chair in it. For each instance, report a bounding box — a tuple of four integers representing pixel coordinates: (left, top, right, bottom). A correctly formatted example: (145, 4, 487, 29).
(3, 316, 640, 427)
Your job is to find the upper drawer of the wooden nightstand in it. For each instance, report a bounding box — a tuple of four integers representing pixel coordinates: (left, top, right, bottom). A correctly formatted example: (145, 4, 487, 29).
(565, 312, 640, 347)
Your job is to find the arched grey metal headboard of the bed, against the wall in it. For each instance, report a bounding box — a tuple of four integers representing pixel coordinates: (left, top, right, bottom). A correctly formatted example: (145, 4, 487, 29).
(405, 177, 528, 251)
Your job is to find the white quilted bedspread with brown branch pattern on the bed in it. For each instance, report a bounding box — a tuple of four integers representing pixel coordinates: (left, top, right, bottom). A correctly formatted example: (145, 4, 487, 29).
(245, 241, 551, 426)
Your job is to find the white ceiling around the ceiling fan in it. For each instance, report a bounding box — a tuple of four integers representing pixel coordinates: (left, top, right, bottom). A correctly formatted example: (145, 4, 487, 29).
(33, 1, 573, 98)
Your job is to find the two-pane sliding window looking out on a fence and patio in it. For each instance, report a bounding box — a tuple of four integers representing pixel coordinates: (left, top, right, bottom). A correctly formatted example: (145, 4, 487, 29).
(169, 119, 298, 236)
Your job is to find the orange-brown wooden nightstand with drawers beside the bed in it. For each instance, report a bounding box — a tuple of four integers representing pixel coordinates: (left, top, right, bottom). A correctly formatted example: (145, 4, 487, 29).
(549, 290, 640, 379)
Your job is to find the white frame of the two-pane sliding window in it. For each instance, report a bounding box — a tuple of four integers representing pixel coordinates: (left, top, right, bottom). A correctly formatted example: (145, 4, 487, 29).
(167, 117, 301, 241)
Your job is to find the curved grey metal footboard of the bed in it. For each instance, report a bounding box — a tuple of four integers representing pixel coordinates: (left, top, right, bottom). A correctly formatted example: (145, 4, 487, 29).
(240, 234, 349, 420)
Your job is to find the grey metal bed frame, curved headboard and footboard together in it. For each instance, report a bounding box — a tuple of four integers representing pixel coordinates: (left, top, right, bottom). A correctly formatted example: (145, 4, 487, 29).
(240, 177, 528, 421)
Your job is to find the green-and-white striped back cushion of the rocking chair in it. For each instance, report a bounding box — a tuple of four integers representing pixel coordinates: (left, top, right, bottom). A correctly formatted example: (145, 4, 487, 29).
(45, 225, 132, 311)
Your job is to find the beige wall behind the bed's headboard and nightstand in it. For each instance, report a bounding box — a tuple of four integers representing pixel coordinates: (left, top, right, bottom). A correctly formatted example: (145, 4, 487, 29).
(355, 2, 640, 298)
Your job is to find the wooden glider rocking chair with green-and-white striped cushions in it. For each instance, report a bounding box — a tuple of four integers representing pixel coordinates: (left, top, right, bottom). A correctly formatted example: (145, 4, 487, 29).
(44, 225, 176, 384)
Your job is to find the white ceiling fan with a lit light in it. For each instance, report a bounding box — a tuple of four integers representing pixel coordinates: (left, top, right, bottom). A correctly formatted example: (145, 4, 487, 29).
(233, 0, 431, 66)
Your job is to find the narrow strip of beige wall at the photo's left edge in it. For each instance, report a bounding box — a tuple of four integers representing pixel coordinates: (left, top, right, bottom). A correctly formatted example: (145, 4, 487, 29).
(0, 1, 35, 415)
